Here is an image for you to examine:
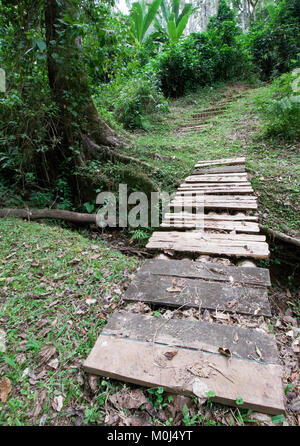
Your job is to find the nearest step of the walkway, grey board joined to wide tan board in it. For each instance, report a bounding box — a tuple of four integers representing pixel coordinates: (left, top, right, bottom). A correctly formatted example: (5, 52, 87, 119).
(83, 313, 284, 414)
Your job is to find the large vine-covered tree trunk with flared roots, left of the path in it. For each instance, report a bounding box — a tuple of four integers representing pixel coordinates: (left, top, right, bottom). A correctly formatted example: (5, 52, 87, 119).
(45, 0, 124, 169)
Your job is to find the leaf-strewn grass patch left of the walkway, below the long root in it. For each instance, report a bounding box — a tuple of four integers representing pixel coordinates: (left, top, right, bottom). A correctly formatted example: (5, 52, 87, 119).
(0, 219, 138, 425)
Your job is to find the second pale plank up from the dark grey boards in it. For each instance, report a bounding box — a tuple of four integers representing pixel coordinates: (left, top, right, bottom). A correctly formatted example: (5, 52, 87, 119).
(160, 214, 260, 233)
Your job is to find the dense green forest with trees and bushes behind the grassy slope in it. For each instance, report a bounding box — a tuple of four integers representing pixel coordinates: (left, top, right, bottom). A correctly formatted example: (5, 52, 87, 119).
(0, 0, 300, 210)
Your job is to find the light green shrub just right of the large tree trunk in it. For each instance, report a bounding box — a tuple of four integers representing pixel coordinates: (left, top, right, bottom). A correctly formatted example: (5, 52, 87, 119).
(95, 72, 168, 130)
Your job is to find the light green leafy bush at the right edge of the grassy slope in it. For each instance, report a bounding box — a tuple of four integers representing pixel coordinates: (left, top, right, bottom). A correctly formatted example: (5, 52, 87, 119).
(258, 70, 300, 140)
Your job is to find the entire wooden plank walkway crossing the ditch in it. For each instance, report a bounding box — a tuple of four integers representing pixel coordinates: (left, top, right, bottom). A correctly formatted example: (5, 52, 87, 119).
(84, 158, 284, 414)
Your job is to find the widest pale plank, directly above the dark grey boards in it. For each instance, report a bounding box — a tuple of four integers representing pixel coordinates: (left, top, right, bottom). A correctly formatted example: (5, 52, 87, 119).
(146, 231, 269, 259)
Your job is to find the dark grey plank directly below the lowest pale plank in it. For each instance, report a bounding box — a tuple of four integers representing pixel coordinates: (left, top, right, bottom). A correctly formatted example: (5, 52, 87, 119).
(139, 259, 271, 288)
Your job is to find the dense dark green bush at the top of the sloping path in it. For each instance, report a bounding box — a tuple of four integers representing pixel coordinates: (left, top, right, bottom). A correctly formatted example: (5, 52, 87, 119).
(152, 2, 253, 97)
